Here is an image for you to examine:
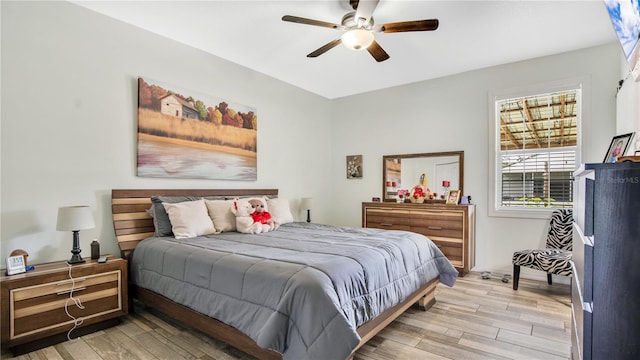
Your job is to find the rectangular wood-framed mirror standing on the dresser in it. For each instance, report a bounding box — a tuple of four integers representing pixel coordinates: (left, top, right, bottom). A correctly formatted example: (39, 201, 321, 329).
(382, 151, 464, 203)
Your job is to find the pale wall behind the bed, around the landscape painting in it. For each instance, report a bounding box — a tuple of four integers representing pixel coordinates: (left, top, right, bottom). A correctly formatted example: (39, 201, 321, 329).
(0, 1, 331, 264)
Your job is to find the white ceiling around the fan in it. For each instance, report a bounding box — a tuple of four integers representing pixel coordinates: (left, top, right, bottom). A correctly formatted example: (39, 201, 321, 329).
(72, 0, 616, 99)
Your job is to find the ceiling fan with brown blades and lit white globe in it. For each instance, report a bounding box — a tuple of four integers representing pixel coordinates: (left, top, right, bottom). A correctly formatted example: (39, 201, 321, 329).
(282, 0, 439, 62)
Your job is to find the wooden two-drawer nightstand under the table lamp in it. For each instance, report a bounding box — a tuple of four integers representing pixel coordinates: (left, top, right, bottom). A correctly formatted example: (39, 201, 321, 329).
(0, 257, 128, 355)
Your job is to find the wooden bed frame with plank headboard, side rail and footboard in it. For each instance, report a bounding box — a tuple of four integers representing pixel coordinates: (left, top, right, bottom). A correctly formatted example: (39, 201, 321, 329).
(111, 189, 439, 360)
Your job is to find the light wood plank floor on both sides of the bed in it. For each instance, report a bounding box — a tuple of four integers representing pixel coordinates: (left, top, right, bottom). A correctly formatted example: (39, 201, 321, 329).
(2, 273, 571, 360)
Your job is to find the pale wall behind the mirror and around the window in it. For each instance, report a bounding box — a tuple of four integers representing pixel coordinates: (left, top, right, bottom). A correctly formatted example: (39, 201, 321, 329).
(331, 43, 620, 277)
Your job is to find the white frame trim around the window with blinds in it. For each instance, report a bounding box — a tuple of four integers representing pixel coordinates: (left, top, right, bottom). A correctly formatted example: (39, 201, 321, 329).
(487, 76, 590, 219)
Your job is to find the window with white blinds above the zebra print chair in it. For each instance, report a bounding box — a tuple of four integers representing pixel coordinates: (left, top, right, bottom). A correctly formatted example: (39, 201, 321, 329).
(492, 85, 581, 215)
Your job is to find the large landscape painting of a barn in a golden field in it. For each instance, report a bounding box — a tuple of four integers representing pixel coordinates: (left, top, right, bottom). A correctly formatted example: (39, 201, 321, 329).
(137, 78, 258, 181)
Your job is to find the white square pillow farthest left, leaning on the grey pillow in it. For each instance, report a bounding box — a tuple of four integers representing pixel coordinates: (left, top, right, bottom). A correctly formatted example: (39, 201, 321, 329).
(162, 199, 216, 239)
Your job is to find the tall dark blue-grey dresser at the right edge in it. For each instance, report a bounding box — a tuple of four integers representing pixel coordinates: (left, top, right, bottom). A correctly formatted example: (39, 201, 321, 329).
(571, 163, 640, 360)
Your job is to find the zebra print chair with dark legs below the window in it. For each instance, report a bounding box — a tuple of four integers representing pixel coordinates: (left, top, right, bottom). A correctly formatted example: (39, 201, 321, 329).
(512, 209, 573, 290)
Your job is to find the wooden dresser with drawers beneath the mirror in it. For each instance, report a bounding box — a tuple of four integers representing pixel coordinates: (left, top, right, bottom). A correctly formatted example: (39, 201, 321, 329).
(362, 202, 476, 276)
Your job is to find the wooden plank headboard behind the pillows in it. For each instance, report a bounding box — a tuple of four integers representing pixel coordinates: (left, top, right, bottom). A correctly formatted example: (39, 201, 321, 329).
(111, 189, 278, 258)
